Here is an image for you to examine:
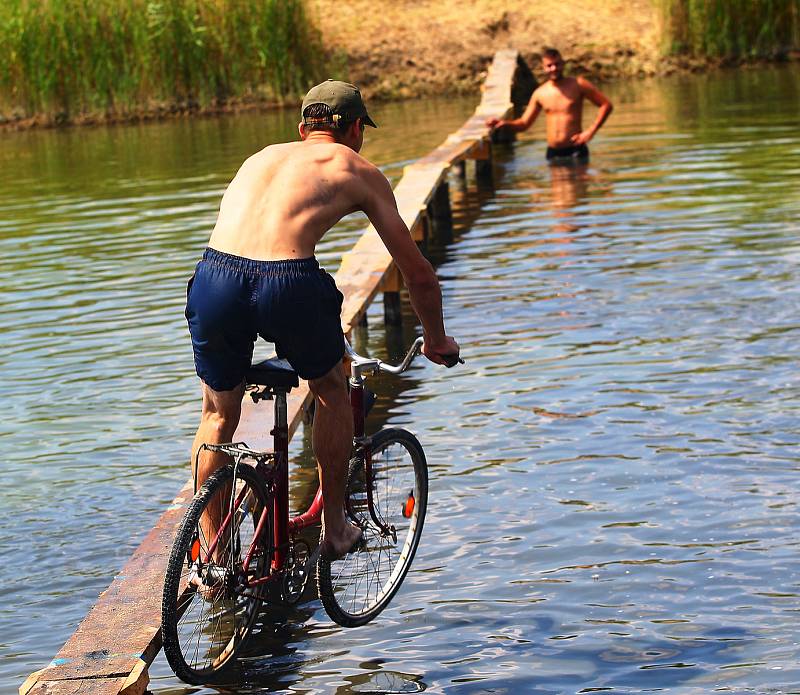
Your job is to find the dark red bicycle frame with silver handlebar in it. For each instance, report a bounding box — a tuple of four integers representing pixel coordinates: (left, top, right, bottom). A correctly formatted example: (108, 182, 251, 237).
(199, 338, 422, 588)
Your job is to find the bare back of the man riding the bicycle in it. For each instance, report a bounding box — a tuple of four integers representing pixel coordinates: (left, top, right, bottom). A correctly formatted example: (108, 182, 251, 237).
(209, 141, 374, 260)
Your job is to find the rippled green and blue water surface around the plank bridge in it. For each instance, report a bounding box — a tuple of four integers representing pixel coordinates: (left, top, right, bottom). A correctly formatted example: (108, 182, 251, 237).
(0, 68, 800, 694)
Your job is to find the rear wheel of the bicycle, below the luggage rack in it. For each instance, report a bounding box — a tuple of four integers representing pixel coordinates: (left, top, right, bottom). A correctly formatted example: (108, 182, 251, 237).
(161, 463, 272, 684)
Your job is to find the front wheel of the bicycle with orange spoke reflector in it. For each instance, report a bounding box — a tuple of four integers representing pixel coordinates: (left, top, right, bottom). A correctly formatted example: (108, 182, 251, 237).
(317, 429, 428, 627)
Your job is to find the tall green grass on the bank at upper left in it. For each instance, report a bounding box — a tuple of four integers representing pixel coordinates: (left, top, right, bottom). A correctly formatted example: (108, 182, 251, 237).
(0, 0, 324, 118)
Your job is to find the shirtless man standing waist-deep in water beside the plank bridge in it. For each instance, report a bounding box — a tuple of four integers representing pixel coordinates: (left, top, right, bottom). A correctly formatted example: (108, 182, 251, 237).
(486, 48, 614, 162)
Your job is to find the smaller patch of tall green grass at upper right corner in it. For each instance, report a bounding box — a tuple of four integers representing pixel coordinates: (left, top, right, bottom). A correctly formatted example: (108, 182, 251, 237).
(657, 0, 800, 58)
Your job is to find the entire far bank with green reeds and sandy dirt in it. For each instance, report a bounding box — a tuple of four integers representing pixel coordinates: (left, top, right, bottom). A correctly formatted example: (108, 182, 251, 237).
(0, 0, 800, 127)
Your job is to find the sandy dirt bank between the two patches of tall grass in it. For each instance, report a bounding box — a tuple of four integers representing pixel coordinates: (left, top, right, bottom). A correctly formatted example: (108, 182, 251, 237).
(308, 0, 669, 98)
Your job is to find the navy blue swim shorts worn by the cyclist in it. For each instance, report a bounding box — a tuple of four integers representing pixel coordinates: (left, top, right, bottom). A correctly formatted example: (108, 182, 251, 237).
(186, 248, 344, 391)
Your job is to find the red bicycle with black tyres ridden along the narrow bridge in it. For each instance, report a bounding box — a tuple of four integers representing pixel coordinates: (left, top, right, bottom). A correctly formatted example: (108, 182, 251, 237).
(161, 338, 450, 684)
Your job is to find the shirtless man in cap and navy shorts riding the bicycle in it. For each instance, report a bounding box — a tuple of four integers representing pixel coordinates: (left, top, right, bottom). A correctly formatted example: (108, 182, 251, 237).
(186, 80, 459, 559)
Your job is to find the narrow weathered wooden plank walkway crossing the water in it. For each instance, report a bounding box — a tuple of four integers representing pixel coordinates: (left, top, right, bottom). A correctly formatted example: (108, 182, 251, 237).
(19, 50, 520, 695)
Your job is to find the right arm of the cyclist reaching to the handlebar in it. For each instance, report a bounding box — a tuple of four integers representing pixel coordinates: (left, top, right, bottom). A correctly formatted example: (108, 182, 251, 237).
(361, 165, 459, 364)
